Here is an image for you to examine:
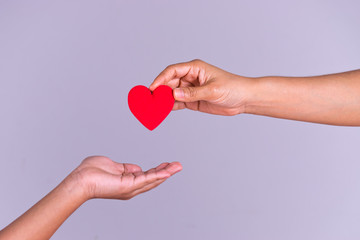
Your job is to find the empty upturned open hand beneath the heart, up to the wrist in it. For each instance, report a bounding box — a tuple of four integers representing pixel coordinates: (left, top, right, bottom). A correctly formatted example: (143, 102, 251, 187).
(72, 156, 182, 200)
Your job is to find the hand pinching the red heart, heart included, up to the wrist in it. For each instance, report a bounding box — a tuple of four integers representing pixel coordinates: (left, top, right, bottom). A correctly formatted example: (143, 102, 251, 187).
(128, 60, 254, 130)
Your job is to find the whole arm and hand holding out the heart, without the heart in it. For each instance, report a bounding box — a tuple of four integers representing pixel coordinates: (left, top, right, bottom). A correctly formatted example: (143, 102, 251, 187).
(150, 60, 360, 126)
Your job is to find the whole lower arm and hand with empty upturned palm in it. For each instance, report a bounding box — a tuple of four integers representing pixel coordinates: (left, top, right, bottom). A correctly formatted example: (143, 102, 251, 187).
(0, 156, 182, 240)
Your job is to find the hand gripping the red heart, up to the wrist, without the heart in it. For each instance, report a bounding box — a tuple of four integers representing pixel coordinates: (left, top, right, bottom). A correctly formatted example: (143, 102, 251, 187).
(150, 60, 252, 116)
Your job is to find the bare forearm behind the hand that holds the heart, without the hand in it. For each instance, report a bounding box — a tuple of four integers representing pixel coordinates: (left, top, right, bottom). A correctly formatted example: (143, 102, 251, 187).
(246, 70, 360, 126)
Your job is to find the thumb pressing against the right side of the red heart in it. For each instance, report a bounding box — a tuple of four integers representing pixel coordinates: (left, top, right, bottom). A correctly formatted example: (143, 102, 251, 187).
(174, 86, 210, 102)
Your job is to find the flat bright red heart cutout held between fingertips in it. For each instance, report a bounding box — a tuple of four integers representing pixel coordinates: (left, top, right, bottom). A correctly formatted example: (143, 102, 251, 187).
(128, 85, 175, 131)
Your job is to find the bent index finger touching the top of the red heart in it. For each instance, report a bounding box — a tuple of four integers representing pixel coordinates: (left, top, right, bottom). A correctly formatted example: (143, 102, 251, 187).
(149, 62, 191, 91)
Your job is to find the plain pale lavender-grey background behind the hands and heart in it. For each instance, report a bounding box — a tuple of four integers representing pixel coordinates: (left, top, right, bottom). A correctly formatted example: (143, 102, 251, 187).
(0, 0, 360, 240)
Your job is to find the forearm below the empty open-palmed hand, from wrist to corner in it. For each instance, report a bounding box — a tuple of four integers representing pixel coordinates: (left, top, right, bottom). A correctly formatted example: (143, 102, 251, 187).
(0, 174, 86, 240)
